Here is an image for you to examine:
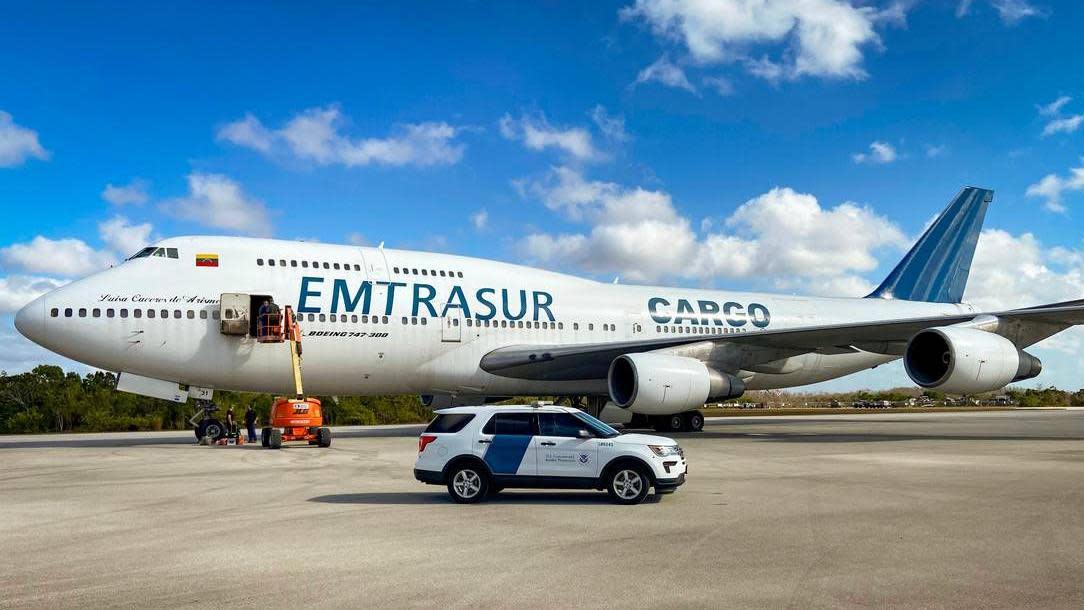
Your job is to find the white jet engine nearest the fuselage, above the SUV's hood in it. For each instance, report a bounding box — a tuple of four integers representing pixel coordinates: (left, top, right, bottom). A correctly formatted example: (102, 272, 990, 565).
(607, 353, 745, 415)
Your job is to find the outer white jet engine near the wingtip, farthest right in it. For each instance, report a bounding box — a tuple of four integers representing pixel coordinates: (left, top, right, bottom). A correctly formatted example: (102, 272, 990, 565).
(903, 326, 1043, 394)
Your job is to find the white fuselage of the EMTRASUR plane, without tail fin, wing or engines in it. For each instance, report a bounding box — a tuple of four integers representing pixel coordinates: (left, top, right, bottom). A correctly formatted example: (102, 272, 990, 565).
(18, 237, 973, 395)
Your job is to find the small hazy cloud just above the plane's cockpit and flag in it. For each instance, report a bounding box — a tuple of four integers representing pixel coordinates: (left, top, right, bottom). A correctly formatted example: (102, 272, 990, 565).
(163, 173, 271, 235)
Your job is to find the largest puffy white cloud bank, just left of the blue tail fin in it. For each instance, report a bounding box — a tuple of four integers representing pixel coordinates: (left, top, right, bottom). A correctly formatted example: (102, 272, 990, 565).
(519, 168, 906, 284)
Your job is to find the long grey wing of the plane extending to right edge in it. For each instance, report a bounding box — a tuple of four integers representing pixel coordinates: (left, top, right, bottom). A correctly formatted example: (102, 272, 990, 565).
(480, 300, 1084, 381)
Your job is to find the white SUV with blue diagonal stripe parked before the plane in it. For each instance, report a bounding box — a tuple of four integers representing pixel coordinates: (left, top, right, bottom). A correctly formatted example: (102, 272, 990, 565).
(414, 406, 686, 504)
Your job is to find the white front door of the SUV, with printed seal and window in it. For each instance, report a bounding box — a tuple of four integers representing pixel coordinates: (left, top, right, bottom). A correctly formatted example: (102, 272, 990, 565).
(534, 413, 598, 478)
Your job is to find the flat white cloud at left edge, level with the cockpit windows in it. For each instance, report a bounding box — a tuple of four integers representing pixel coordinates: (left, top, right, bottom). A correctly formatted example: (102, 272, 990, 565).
(0, 235, 117, 277)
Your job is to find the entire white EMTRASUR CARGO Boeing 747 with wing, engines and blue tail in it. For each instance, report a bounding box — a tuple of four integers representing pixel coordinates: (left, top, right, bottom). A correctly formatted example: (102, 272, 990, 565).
(15, 187, 1084, 429)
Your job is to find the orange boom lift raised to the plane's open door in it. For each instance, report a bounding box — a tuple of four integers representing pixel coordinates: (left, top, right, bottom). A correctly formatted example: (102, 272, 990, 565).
(259, 306, 332, 449)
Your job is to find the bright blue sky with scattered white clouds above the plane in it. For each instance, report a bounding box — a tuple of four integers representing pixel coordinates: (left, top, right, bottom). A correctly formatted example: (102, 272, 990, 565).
(0, 0, 1084, 388)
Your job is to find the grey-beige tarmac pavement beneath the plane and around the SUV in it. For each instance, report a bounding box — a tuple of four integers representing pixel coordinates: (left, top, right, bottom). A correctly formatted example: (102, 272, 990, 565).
(0, 410, 1084, 609)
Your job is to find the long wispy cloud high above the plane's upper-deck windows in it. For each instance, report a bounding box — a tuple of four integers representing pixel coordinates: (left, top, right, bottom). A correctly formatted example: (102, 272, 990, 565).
(217, 105, 464, 167)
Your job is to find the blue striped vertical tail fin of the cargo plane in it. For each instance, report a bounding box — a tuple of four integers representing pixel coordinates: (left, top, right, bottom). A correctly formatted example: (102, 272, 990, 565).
(866, 186, 994, 303)
